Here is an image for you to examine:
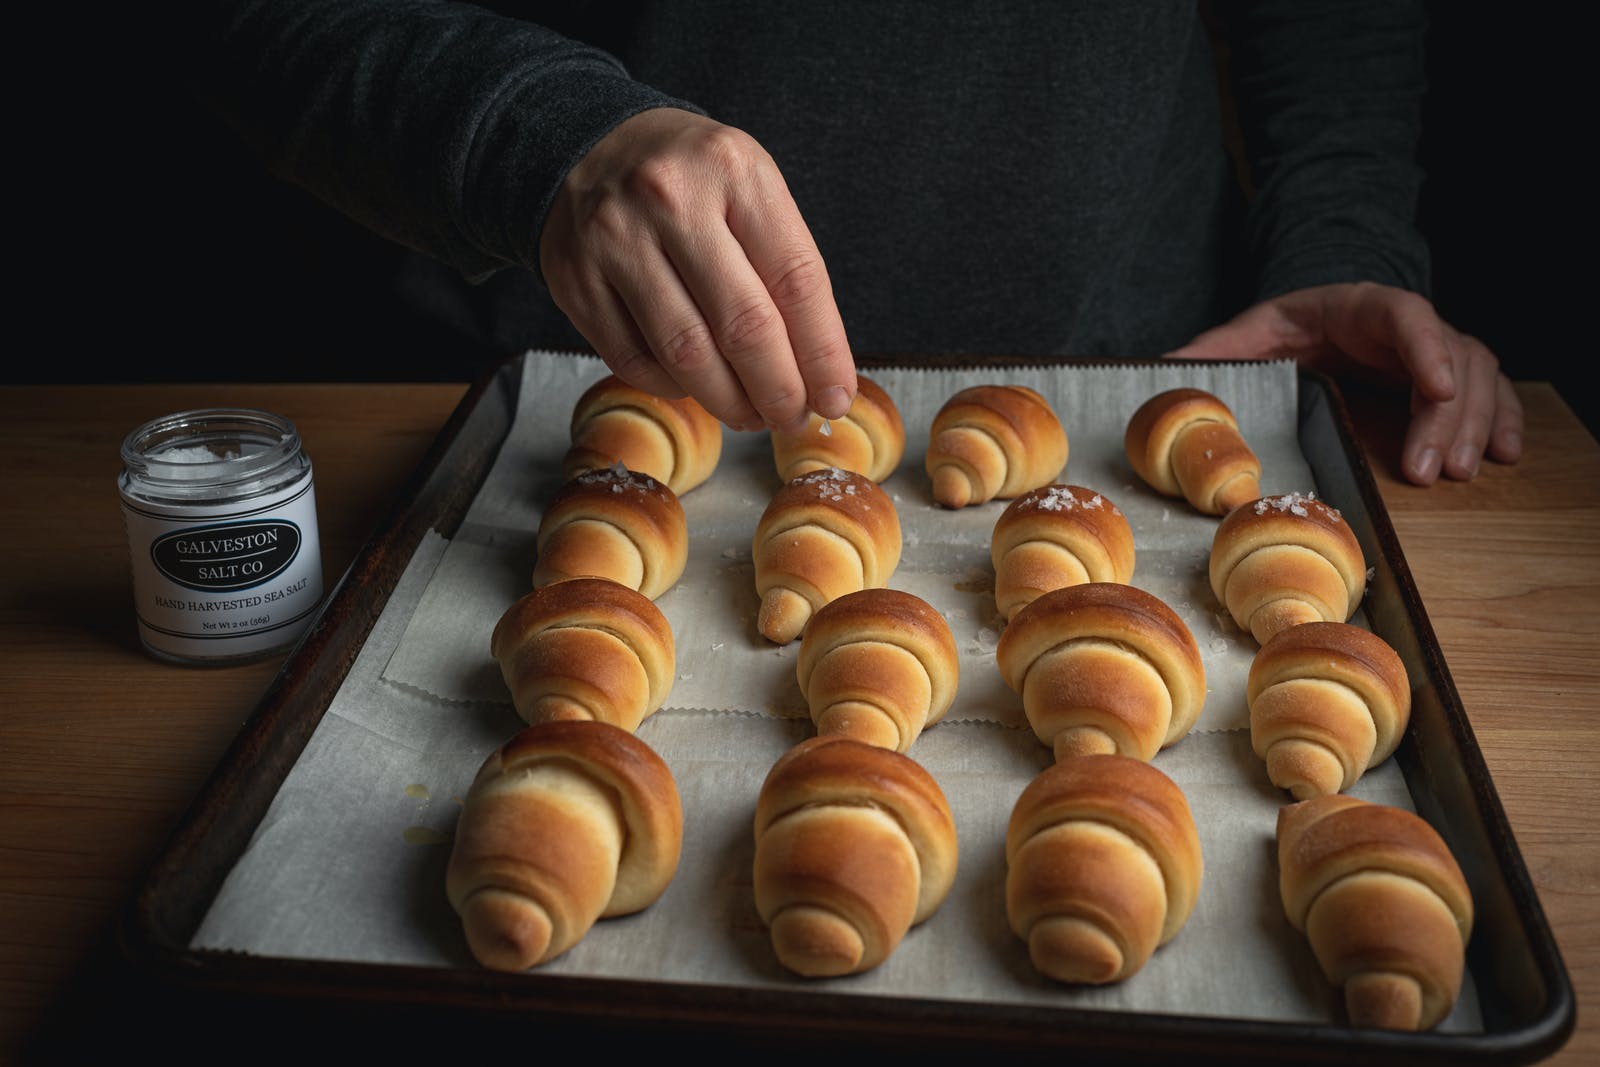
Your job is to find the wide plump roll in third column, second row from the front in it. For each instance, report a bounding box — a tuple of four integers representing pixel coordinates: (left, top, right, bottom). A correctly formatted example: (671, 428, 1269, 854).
(995, 582, 1205, 760)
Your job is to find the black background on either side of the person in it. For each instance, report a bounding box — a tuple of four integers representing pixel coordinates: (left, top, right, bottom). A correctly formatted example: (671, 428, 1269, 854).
(21, 2, 1600, 434)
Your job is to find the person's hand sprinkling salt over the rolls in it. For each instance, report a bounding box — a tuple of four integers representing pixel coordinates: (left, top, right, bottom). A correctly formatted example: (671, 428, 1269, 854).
(539, 107, 856, 430)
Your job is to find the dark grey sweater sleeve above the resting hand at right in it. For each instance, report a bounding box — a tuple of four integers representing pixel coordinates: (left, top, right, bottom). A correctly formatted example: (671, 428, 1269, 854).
(1216, 0, 1430, 299)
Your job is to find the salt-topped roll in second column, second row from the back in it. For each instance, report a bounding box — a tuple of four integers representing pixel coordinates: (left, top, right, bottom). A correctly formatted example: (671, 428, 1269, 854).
(750, 467, 901, 645)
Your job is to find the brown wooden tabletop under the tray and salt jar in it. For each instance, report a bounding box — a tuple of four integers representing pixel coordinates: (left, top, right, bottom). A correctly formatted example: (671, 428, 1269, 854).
(0, 374, 1600, 1065)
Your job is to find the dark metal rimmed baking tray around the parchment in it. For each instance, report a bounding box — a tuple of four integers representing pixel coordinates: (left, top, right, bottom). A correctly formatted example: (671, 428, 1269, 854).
(120, 357, 1574, 1064)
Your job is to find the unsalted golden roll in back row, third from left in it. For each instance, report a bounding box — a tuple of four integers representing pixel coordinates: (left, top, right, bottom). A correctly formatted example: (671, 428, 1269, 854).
(923, 386, 1067, 507)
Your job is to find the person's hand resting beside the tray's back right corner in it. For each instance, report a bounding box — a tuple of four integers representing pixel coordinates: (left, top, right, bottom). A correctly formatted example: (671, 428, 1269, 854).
(1168, 282, 1523, 485)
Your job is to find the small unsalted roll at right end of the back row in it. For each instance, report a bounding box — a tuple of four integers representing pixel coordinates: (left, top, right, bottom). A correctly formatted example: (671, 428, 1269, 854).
(1123, 389, 1261, 515)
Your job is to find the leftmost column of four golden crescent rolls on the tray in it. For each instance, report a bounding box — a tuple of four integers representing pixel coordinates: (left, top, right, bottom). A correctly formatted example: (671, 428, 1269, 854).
(445, 376, 722, 971)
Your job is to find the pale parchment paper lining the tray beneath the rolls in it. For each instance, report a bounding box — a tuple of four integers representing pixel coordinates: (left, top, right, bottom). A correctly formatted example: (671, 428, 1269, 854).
(195, 352, 1482, 1032)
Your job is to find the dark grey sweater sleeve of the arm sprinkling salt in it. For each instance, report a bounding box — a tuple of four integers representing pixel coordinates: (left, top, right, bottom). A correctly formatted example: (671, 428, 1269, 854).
(179, 0, 699, 280)
